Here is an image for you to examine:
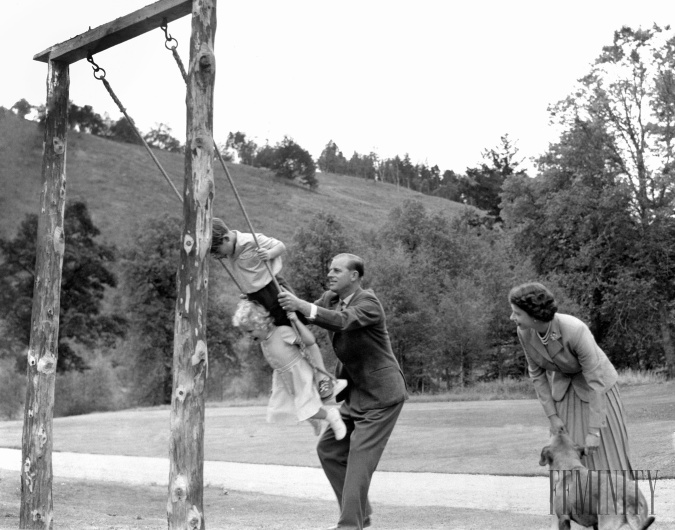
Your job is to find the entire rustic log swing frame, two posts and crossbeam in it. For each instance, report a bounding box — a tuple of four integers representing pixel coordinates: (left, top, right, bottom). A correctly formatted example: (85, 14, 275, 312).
(27, 0, 217, 530)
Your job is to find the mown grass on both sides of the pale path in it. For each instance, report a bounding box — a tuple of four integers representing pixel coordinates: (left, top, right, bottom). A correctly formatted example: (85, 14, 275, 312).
(0, 382, 675, 530)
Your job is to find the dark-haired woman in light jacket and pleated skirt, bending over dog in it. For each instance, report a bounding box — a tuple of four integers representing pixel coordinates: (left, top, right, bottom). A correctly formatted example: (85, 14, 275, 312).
(509, 283, 632, 470)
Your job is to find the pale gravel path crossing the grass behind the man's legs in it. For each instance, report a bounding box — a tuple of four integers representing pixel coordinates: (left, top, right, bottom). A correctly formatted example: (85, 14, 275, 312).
(0, 448, 675, 529)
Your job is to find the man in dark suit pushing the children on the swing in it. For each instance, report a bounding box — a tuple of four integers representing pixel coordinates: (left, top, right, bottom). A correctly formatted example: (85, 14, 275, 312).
(279, 254, 408, 530)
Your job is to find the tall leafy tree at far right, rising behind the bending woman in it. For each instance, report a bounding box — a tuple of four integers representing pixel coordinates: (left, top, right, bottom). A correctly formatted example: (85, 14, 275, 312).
(504, 26, 675, 375)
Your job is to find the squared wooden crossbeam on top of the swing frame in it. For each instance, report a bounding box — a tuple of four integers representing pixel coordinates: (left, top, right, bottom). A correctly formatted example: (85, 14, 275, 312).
(33, 0, 192, 64)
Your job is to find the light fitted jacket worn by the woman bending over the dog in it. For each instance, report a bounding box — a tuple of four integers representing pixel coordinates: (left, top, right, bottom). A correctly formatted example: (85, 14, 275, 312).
(518, 313, 618, 428)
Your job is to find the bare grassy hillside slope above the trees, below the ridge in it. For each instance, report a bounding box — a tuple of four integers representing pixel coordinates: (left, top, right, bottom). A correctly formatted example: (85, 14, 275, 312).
(0, 109, 464, 247)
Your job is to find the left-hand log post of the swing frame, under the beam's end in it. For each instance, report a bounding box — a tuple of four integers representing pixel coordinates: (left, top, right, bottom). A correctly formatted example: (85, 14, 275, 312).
(20, 61, 70, 530)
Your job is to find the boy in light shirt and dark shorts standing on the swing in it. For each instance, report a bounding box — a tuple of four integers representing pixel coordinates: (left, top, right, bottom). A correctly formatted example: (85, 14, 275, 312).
(211, 217, 347, 401)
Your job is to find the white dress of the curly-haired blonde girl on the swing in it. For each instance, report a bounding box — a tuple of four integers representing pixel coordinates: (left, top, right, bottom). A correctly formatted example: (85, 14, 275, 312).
(260, 326, 322, 423)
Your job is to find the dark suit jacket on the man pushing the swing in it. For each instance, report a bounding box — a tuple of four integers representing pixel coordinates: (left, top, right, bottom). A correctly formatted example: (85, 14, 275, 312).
(314, 288, 408, 410)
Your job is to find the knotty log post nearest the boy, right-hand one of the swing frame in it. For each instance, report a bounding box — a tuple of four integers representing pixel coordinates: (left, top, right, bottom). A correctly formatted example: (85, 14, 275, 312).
(167, 0, 216, 530)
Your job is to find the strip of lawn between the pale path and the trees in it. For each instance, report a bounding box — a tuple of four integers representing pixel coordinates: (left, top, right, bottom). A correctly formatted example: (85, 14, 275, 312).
(0, 381, 675, 478)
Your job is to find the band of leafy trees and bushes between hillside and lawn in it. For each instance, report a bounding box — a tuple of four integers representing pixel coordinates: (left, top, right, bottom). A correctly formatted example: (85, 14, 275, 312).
(0, 26, 675, 413)
